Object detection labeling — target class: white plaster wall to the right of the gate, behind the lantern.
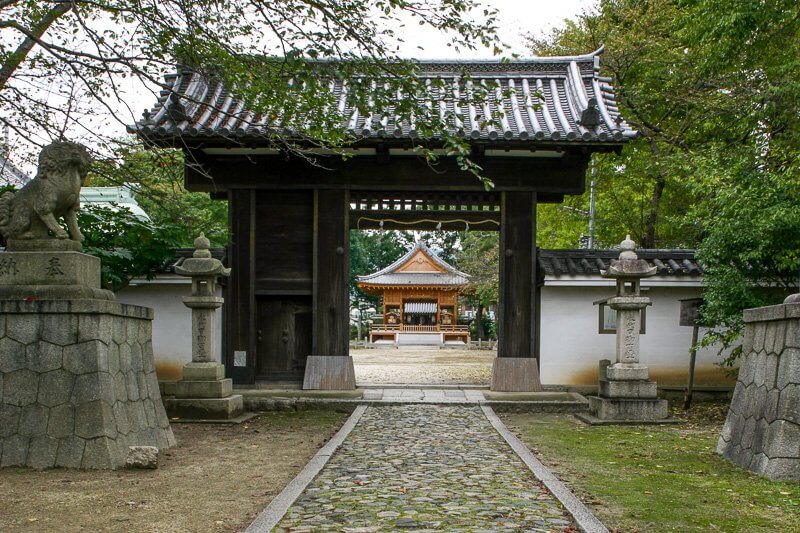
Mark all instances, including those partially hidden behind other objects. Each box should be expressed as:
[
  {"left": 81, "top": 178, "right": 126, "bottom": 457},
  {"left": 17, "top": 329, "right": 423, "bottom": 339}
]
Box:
[{"left": 541, "top": 280, "right": 733, "bottom": 385}]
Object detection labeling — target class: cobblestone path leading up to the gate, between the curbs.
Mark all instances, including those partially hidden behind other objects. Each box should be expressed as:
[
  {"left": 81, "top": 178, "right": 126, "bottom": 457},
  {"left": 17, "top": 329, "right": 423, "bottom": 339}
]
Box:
[{"left": 278, "top": 404, "right": 572, "bottom": 533}]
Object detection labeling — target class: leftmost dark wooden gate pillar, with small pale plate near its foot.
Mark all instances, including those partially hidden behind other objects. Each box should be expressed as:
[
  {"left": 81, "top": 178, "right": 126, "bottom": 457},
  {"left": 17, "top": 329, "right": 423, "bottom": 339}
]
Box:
[{"left": 223, "top": 190, "right": 256, "bottom": 383}]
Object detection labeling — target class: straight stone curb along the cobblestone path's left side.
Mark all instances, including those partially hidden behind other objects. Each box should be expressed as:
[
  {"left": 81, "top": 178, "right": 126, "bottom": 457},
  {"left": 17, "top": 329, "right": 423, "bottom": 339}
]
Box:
[{"left": 245, "top": 405, "right": 368, "bottom": 533}]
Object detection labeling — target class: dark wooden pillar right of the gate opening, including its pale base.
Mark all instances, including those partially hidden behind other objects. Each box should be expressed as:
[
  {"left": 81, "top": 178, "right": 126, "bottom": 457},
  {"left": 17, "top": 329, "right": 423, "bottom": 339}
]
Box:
[{"left": 492, "top": 191, "right": 542, "bottom": 392}]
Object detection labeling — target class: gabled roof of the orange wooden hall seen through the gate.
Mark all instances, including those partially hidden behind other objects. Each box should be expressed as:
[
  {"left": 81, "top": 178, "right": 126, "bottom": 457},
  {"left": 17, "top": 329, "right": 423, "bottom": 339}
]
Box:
[{"left": 357, "top": 241, "right": 469, "bottom": 287}]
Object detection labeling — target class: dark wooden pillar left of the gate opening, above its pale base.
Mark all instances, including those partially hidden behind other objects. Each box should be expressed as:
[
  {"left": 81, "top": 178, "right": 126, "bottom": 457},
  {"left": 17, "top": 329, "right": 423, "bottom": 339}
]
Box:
[{"left": 311, "top": 190, "right": 350, "bottom": 356}]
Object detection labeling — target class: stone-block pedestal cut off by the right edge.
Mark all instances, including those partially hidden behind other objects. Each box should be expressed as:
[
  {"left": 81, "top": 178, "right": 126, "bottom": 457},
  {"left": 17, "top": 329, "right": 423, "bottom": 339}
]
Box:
[{"left": 717, "top": 295, "right": 800, "bottom": 482}]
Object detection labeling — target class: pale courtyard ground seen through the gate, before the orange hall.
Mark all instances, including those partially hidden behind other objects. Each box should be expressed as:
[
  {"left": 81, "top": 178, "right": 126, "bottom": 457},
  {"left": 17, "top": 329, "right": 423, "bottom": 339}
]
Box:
[{"left": 350, "top": 347, "right": 497, "bottom": 386}]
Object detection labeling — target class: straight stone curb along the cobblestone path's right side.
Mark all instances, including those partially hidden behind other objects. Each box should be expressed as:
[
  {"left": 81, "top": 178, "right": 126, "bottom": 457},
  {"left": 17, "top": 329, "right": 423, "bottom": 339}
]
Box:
[{"left": 481, "top": 405, "right": 608, "bottom": 533}]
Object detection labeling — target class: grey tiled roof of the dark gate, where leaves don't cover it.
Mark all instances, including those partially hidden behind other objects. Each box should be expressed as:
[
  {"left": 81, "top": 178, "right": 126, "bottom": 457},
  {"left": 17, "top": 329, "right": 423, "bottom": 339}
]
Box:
[{"left": 129, "top": 48, "right": 637, "bottom": 146}]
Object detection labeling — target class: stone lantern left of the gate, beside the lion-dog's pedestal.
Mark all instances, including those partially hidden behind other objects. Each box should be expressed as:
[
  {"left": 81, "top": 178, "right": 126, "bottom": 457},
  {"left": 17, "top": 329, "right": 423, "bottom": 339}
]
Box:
[{"left": 166, "top": 234, "right": 243, "bottom": 419}]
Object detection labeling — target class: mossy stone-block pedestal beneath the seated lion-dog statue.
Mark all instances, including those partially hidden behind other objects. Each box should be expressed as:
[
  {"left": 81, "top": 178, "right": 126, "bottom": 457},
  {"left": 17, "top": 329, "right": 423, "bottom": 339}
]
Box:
[{"left": 0, "top": 249, "right": 175, "bottom": 469}]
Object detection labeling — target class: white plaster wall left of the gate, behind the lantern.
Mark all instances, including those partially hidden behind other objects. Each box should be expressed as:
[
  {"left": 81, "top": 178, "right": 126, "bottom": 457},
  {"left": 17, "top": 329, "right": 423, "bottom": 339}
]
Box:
[{"left": 116, "top": 276, "right": 222, "bottom": 380}]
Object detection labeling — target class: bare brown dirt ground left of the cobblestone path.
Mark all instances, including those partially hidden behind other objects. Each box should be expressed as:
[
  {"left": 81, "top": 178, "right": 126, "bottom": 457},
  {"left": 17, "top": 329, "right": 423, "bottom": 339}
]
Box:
[{"left": 0, "top": 411, "right": 348, "bottom": 532}]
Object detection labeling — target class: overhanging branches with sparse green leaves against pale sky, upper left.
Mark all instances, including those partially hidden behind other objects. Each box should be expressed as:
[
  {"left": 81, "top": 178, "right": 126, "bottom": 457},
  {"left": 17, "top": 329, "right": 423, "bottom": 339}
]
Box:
[{"left": 0, "top": 0, "right": 499, "bottom": 170}]
